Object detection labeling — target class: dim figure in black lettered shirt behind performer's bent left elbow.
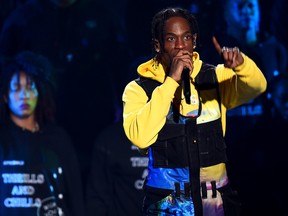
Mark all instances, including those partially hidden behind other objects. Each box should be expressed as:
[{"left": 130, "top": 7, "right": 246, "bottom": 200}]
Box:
[{"left": 86, "top": 118, "right": 148, "bottom": 216}]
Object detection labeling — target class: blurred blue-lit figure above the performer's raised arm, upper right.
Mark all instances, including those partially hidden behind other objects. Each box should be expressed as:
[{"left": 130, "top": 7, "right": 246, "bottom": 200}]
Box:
[{"left": 203, "top": 0, "right": 287, "bottom": 82}]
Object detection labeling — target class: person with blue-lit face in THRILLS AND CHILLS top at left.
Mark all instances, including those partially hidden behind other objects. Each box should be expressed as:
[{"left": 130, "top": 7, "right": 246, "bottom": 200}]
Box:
[{"left": 0, "top": 51, "right": 84, "bottom": 216}]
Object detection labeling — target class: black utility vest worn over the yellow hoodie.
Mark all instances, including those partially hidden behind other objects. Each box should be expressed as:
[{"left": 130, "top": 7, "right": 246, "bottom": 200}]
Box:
[{"left": 136, "top": 63, "right": 227, "bottom": 169}]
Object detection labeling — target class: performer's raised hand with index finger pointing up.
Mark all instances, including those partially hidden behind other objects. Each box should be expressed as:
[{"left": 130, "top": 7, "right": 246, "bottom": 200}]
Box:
[{"left": 212, "top": 36, "right": 244, "bottom": 69}]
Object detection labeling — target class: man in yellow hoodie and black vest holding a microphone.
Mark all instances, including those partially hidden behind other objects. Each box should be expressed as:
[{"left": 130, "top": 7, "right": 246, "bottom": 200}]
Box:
[{"left": 122, "top": 8, "right": 267, "bottom": 216}]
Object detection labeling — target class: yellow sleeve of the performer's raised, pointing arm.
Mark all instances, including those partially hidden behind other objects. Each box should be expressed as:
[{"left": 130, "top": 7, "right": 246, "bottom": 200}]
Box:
[{"left": 216, "top": 53, "right": 267, "bottom": 109}]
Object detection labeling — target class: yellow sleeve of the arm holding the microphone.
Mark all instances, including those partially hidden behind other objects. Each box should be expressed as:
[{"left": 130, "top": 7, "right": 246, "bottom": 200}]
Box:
[{"left": 122, "top": 77, "right": 179, "bottom": 148}]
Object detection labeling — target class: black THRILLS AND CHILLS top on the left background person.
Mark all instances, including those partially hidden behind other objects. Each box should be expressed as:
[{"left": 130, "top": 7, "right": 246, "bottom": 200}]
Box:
[{"left": 0, "top": 122, "right": 83, "bottom": 216}]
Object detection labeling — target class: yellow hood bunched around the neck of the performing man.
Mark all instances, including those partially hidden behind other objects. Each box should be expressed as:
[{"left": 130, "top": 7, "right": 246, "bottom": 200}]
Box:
[{"left": 137, "top": 52, "right": 202, "bottom": 83}]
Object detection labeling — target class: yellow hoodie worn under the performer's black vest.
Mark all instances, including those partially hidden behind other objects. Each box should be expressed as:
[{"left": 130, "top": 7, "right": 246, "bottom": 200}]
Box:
[{"left": 122, "top": 52, "right": 267, "bottom": 149}]
